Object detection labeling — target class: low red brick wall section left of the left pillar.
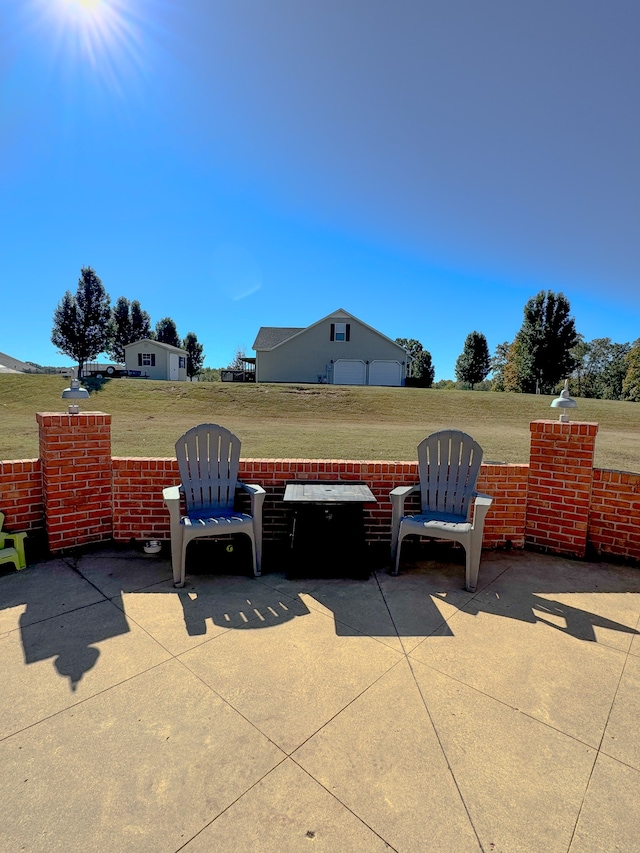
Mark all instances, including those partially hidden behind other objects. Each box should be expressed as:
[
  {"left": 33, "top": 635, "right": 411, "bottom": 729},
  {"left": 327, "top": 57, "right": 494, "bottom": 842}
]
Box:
[{"left": 0, "top": 459, "right": 44, "bottom": 532}]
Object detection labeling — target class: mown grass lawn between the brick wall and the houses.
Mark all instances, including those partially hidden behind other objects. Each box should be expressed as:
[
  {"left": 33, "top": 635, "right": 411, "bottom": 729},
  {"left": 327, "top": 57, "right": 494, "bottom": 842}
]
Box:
[{"left": 0, "top": 374, "right": 640, "bottom": 471}]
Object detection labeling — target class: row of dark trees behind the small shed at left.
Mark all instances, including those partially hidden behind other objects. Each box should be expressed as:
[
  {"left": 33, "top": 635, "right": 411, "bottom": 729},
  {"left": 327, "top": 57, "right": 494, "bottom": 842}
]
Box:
[{"left": 51, "top": 267, "right": 205, "bottom": 379}]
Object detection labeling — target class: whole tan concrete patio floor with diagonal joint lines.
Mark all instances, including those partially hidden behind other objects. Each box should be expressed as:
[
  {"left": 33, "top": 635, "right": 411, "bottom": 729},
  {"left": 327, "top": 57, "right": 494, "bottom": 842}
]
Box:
[{"left": 0, "top": 550, "right": 640, "bottom": 853}]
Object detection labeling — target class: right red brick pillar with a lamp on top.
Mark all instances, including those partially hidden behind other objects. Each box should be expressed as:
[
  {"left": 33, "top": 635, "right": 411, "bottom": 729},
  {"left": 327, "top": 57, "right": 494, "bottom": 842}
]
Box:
[{"left": 525, "top": 420, "right": 598, "bottom": 557}]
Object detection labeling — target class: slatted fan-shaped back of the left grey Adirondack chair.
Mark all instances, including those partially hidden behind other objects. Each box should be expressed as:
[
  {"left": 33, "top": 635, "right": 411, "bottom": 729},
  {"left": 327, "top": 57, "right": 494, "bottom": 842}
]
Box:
[{"left": 176, "top": 424, "right": 240, "bottom": 512}]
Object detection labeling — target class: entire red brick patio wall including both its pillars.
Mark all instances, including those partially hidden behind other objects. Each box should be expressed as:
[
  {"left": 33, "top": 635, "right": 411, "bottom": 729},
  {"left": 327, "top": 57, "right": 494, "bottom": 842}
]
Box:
[{"left": 0, "top": 412, "right": 640, "bottom": 561}]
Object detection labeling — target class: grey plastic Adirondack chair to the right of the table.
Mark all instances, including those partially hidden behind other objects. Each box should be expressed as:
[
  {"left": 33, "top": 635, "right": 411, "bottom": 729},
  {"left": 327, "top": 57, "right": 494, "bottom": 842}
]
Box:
[{"left": 389, "top": 430, "right": 493, "bottom": 592}]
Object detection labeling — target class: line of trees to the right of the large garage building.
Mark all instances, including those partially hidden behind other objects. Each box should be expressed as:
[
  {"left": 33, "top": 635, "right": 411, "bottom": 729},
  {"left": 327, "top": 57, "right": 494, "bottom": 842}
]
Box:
[{"left": 396, "top": 290, "right": 640, "bottom": 401}]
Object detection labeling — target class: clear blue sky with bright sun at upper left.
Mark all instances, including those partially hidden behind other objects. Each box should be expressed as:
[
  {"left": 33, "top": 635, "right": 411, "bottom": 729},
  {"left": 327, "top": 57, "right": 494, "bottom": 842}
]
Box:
[{"left": 0, "top": 0, "right": 640, "bottom": 380}]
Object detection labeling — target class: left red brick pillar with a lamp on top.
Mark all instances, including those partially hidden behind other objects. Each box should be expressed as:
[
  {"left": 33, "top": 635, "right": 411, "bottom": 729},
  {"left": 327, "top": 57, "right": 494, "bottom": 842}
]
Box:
[{"left": 36, "top": 412, "right": 113, "bottom": 551}]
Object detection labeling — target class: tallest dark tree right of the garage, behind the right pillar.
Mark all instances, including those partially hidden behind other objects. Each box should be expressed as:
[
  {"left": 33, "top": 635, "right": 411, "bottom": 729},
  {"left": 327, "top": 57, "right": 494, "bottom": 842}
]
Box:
[{"left": 514, "top": 290, "right": 578, "bottom": 394}]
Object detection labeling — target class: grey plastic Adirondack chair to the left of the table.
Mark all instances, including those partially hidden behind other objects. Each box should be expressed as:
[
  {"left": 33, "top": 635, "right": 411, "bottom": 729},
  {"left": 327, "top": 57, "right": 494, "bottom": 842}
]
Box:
[{"left": 162, "top": 424, "right": 266, "bottom": 587}]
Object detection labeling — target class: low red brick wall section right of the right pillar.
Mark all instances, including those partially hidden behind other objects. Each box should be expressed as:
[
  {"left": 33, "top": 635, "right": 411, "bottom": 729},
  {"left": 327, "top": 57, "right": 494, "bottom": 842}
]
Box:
[{"left": 589, "top": 468, "right": 640, "bottom": 560}]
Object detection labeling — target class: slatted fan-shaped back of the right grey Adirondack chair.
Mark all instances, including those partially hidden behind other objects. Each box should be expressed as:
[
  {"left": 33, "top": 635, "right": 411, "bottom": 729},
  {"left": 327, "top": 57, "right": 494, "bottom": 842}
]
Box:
[{"left": 418, "top": 429, "right": 482, "bottom": 518}]
